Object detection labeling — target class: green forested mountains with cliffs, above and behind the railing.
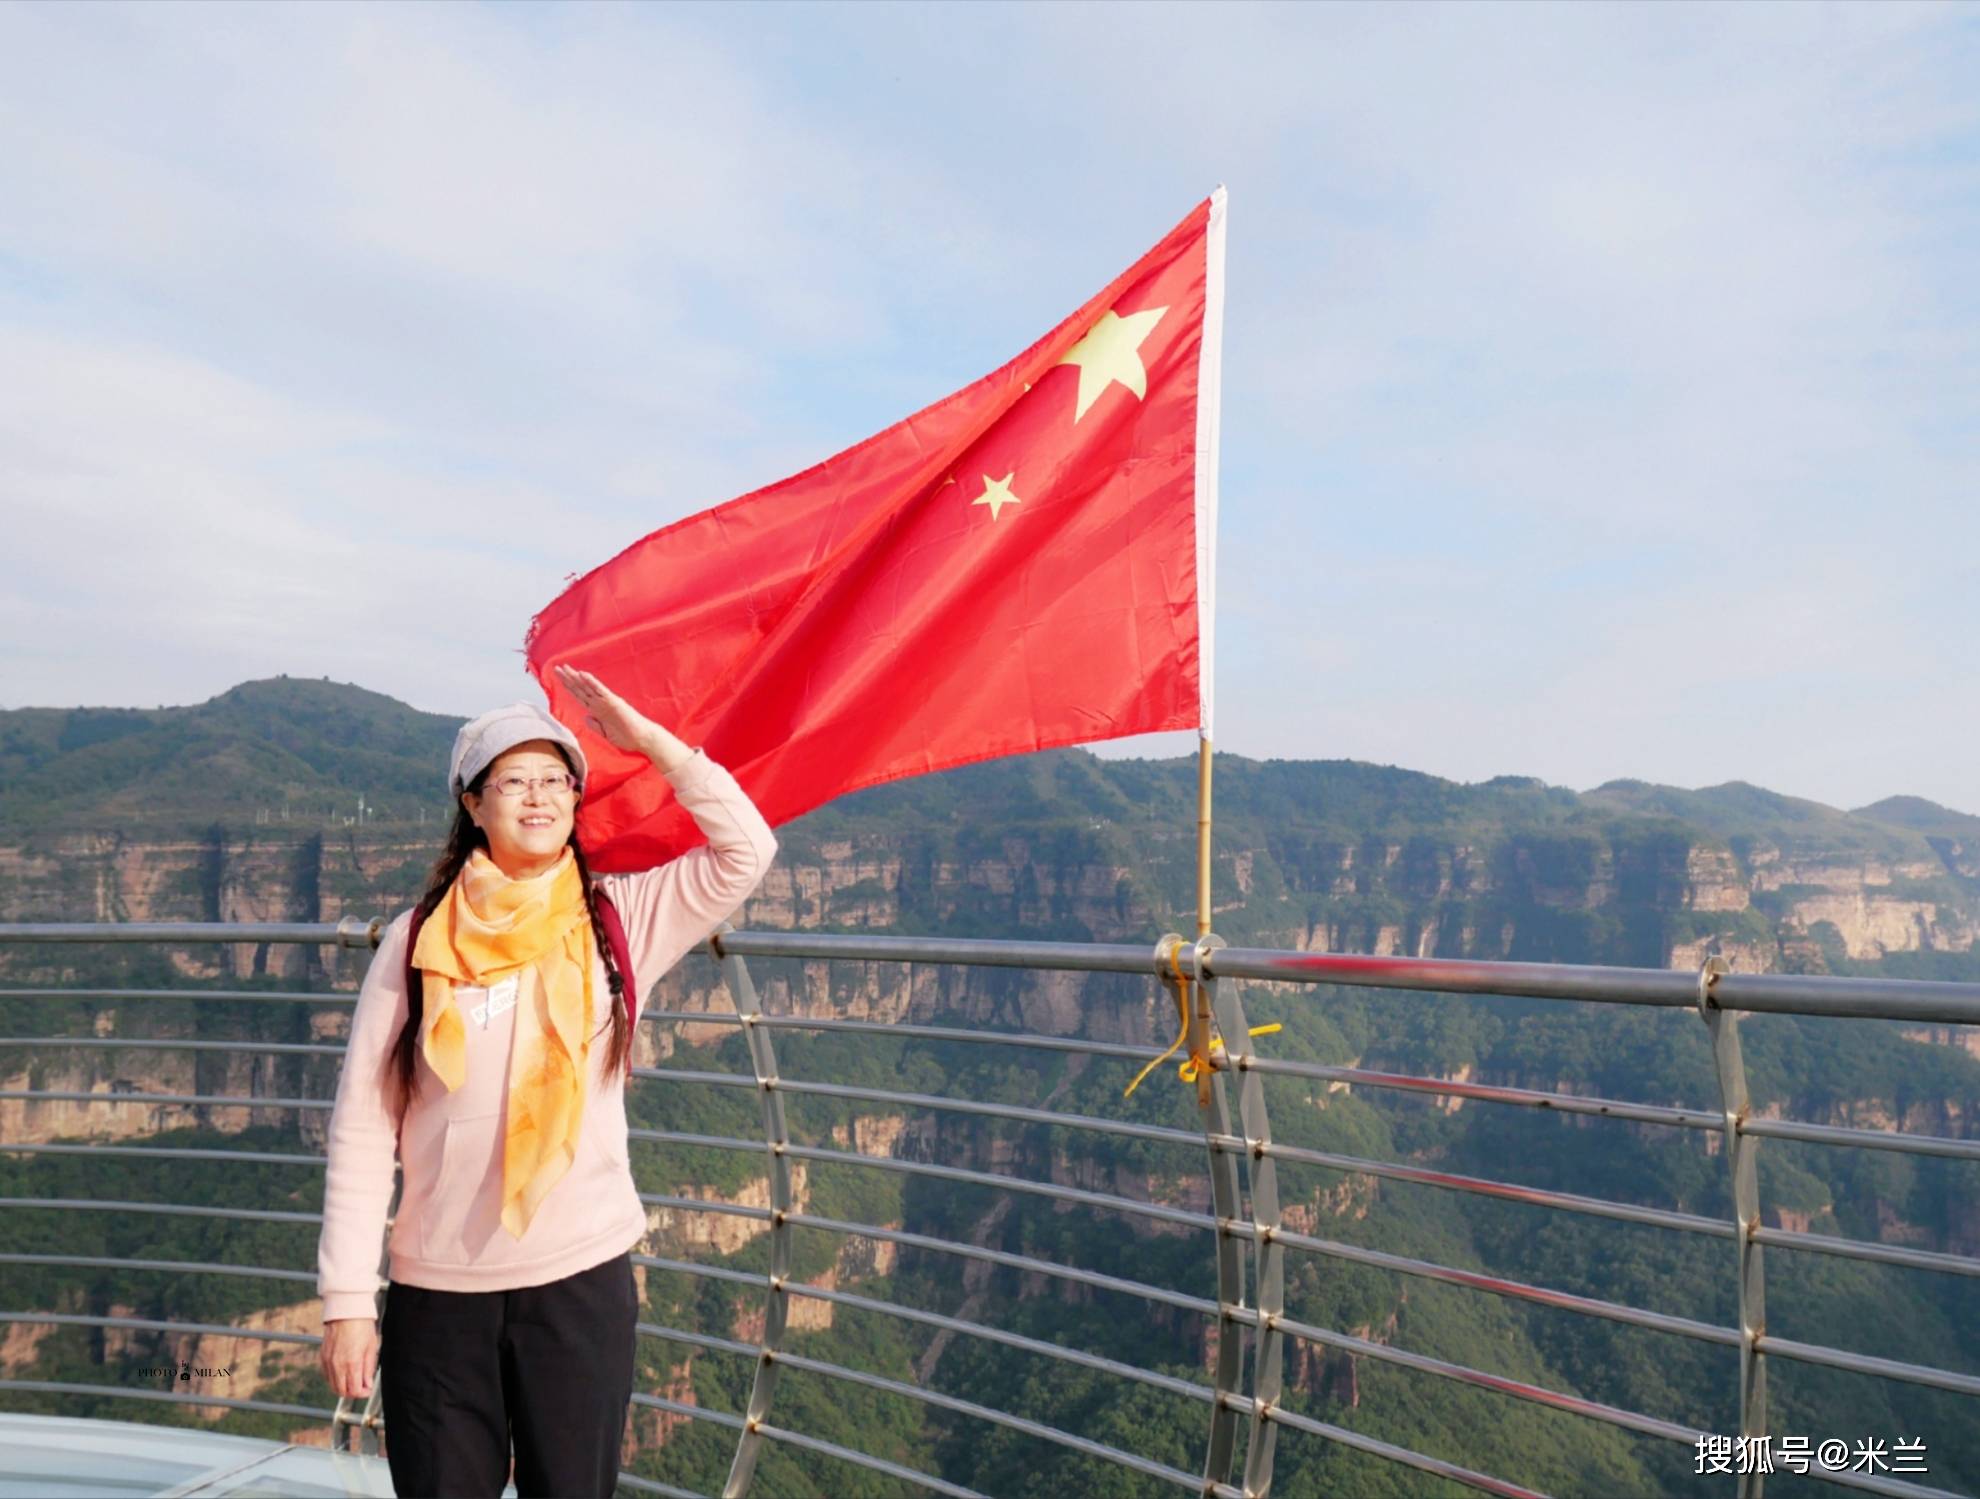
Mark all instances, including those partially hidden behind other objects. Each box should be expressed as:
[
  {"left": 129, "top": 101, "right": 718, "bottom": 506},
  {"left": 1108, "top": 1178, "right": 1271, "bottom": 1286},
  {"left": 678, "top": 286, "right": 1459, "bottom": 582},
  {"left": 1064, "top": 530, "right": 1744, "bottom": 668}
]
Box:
[{"left": 0, "top": 679, "right": 1980, "bottom": 1499}]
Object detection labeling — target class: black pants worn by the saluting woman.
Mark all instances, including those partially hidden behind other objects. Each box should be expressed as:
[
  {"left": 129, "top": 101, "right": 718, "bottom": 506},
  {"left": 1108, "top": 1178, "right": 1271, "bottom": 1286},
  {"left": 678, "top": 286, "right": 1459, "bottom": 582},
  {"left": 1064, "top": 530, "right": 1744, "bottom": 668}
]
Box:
[{"left": 378, "top": 1255, "right": 638, "bottom": 1499}]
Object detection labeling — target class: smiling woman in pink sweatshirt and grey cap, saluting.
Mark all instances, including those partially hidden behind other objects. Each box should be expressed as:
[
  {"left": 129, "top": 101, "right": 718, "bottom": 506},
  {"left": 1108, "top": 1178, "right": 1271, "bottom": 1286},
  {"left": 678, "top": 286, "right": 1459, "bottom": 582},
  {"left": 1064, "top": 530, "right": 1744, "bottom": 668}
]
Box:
[{"left": 317, "top": 667, "right": 776, "bottom": 1495}]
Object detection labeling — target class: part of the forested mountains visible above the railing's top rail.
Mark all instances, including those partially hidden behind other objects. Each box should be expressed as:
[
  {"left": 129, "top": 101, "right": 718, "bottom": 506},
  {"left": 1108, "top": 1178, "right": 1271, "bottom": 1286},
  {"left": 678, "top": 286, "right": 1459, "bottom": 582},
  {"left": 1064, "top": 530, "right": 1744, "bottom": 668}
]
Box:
[{"left": 0, "top": 677, "right": 1980, "bottom": 976}]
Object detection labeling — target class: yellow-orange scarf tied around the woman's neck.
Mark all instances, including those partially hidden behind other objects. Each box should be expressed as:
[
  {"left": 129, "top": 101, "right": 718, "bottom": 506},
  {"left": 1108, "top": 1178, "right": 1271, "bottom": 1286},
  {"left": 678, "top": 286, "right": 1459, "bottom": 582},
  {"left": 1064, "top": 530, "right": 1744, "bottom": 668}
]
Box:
[{"left": 412, "top": 848, "right": 592, "bottom": 1238}]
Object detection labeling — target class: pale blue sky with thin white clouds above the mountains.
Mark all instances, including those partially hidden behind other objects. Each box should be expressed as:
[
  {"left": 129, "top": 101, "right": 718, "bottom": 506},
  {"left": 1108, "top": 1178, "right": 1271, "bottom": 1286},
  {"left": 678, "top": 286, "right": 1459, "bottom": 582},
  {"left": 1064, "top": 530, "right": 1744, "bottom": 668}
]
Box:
[{"left": 0, "top": 2, "right": 1980, "bottom": 810}]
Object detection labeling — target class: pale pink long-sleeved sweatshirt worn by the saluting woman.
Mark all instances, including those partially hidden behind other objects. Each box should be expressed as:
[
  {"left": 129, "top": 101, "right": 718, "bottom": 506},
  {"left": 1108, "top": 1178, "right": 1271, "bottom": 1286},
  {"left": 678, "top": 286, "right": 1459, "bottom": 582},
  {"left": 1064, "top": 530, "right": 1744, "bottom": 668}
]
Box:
[{"left": 317, "top": 750, "right": 776, "bottom": 1323}]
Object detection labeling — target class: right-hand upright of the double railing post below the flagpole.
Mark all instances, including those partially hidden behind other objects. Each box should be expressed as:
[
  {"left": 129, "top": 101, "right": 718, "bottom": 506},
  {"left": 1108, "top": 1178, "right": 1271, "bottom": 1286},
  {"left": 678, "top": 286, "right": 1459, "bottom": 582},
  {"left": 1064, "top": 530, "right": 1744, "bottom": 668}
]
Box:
[{"left": 1196, "top": 935, "right": 1285, "bottom": 1499}]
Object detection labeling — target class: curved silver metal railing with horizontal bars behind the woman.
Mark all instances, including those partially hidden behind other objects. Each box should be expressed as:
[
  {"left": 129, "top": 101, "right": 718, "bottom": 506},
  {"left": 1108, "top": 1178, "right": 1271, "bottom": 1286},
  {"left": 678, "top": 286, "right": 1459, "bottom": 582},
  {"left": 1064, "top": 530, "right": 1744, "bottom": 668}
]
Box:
[{"left": 0, "top": 921, "right": 1980, "bottom": 1499}]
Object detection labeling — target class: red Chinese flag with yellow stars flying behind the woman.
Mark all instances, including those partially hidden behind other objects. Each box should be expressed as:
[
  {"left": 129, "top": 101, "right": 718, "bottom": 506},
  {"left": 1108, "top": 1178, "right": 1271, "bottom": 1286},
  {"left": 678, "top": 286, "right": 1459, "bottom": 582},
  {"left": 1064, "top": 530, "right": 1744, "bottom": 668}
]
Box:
[{"left": 529, "top": 188, "right": 1224, "bottom": 869}]
